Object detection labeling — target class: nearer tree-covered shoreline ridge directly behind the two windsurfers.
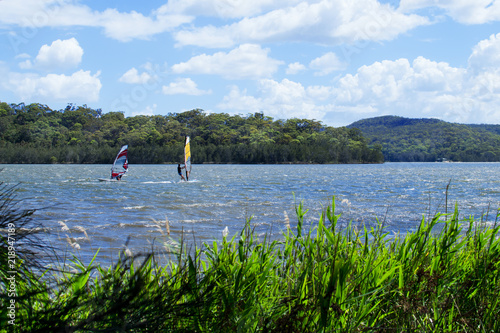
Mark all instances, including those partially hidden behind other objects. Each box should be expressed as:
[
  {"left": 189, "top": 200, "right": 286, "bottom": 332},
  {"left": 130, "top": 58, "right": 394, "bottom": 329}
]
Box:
[{"left": 0, "top": 103, "right": 383, "bottom": 164}]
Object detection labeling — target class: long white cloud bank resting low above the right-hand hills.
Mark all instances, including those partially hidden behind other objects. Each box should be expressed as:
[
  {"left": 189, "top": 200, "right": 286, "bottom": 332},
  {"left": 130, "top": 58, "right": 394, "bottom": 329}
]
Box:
[{"left": 219, "top": 35, "right": 500, "bottom": 126}]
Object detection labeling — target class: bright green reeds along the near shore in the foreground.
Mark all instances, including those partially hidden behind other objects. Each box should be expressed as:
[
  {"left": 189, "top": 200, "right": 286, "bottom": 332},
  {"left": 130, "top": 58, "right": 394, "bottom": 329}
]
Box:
[{"left": 0, "top": 199, "right": 500, "bottom": 332}]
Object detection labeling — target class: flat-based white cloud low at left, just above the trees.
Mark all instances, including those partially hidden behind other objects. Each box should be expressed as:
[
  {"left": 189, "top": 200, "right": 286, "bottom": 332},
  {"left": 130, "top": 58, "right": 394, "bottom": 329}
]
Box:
[{"left": 3, "top": 70, "right": 102, "bottom": 103}]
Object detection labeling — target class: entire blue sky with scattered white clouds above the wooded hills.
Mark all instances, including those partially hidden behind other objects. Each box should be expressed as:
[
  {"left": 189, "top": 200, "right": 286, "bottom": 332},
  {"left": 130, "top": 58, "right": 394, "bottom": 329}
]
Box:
[{"left": 0, "top": 0, "right": 500, "bottom": 126}]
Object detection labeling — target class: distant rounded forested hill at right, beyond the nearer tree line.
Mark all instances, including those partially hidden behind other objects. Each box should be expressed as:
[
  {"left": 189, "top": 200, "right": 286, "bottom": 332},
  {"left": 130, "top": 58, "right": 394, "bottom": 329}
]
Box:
[{"left": 348, "top": 116, "right": 500, "bottom": 162}]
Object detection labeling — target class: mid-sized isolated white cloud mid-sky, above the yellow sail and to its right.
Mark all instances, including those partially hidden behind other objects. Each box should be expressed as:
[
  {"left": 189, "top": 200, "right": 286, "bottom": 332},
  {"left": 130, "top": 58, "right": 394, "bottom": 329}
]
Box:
[{"left": 172, "top": 44, "right": 283, "bottom": 79}]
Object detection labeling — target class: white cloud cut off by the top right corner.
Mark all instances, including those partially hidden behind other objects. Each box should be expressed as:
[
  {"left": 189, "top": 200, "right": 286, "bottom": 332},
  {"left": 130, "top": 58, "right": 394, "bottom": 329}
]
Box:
[{"left": 399, "top": 0, "right": 500, "bottom": 24}]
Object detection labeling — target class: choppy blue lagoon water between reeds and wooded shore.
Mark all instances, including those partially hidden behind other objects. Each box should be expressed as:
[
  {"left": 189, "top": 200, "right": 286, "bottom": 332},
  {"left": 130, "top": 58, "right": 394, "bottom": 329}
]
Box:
[{"left": 0, "top": 163, "right": 500, "bottom": 261}]
